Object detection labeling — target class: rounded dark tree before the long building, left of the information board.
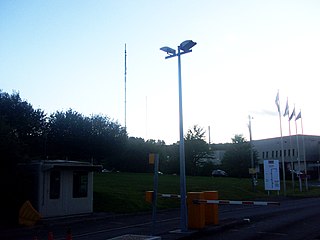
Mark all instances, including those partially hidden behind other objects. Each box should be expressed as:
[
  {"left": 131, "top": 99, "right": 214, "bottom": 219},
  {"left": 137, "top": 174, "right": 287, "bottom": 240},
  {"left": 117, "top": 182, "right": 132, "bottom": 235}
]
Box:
[{"left": 222, "top": 134, "right": 258, "bottom": 177}]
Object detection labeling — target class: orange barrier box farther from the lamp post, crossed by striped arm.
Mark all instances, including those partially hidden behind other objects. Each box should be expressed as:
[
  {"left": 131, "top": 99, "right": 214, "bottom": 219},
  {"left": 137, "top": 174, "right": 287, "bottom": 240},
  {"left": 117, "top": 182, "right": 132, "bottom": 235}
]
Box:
[{"left": 203, "top": 191, "right": 219, "bottom": 225}]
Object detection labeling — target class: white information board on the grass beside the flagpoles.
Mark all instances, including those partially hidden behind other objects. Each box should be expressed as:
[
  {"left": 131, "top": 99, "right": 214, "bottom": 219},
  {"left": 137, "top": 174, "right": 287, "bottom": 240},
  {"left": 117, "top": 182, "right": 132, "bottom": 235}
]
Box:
[{"left": 263, "top": 160, "right": 280, "bottom": 191}]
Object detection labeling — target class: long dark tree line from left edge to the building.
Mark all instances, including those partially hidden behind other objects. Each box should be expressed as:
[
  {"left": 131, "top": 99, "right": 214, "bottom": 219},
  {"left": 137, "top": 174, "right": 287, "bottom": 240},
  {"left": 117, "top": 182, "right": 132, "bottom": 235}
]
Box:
[{"left": 0, "top": 90, "right": 258, "bottom": 225}]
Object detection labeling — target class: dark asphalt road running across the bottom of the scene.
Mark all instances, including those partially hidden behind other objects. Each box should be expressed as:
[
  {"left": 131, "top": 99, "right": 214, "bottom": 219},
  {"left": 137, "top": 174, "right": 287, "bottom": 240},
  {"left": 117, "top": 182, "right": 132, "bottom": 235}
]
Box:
[{"left": 0, "top": 198, "right": 320, "bottom": 240}]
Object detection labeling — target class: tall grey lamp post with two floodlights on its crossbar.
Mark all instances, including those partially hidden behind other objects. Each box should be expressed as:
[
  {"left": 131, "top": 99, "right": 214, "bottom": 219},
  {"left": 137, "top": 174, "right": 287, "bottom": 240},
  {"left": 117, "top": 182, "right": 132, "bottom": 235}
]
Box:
[{"left": 160, "top": 40, "right": 197, "bottom": 232}]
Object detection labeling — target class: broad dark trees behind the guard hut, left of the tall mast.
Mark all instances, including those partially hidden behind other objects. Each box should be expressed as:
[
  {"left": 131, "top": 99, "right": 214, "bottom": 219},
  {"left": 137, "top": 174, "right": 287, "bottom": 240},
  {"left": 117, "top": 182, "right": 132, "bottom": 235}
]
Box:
[{"left": 48, "top": 109, "right": 127, "bottom": 163}]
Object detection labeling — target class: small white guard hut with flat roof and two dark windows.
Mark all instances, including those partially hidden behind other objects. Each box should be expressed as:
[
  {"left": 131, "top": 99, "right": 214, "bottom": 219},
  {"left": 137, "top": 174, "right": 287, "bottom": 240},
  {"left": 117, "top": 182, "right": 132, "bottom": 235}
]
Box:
[{"left": 17, "top": 160, "right": 102, "bottom": 218}]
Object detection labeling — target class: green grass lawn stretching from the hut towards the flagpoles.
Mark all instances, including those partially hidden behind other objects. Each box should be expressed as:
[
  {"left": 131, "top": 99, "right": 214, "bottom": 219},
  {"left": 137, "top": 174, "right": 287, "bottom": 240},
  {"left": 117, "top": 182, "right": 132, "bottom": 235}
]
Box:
[{"left": 93, "top": 173, "right": 320, "bottom": 213}]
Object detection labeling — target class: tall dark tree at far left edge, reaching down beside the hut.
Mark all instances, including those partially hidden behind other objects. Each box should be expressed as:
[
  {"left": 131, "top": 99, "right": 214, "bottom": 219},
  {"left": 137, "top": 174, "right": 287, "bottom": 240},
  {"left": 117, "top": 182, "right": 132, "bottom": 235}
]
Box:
[{"left": 0, "top": 90, "right": 46, "bottom": 224}]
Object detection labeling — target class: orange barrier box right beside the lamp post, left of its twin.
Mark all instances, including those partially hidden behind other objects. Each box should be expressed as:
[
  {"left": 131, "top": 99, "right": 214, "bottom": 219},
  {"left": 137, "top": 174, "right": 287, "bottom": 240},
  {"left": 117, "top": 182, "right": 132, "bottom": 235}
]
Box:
[{"left": 187, "top": 192, "right": 205, "bottom": 229}]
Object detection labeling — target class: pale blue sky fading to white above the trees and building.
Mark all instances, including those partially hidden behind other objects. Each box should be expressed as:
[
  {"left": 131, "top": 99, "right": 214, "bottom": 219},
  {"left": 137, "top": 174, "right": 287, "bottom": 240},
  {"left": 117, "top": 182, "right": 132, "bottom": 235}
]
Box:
[{"left": 0, "top": 0, "right": 320, "bottom": 144}]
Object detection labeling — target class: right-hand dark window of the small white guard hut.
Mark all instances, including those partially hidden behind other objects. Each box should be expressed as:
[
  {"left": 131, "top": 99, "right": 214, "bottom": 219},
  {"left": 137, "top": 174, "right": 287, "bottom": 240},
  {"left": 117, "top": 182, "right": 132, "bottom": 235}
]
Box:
[{"left": 73, "top": 171, "right": 88, "bottom": 198}]
